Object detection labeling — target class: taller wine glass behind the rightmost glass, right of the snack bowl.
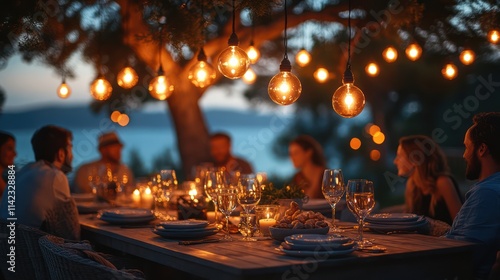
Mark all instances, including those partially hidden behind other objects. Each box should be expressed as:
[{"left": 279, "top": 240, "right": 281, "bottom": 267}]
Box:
[{"left": 321, "top": 169, "right": 345, "bottom": 233}]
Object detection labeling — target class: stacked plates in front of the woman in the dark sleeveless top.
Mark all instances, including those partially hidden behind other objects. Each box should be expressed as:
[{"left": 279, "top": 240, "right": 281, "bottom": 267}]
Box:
[{"left": 365, "top": 213, "right": 429, "bottom": 232}]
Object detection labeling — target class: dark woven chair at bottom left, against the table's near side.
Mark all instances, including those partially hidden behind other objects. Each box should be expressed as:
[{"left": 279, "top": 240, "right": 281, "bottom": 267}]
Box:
[{"left": 39, "top": 235, "right": 144, "bottom": 280}]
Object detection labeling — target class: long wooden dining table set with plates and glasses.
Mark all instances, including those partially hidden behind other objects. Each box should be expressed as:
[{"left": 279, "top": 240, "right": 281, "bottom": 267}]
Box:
[{"left": 80, "top": 214, "right": 474, "bottom": 280}]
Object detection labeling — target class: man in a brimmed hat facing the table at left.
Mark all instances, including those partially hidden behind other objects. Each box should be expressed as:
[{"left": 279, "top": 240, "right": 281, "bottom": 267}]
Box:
[{"left": 71, "top": 132, "right": 134, "bottom": 193}]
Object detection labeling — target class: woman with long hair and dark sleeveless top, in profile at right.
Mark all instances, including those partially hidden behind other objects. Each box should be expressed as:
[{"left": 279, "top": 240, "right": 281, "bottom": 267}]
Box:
[{"left": 394, "top": 135, "right": 463, "bottom": 225}]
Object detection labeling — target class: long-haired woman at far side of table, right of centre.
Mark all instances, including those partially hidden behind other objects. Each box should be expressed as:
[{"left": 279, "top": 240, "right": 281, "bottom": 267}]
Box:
[{"left": 288, "top": 135, "right": 326, "bottom": 198}]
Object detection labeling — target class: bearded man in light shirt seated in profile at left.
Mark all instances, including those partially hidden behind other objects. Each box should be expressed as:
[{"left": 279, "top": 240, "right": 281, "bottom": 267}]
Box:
[{"left": 0, "top": 125, "right": 80, "bottom": 240}]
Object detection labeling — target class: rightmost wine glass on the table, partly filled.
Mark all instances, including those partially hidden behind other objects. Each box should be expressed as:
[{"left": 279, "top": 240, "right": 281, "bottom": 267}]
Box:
[{"left": 346, "top": 179, "right": 375, "bottom": 248}]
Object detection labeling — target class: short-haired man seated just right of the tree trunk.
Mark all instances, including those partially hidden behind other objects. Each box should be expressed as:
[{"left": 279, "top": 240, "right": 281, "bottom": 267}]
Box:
[{"left": 210, "top": 133, "right": 253, "bottom": 174}]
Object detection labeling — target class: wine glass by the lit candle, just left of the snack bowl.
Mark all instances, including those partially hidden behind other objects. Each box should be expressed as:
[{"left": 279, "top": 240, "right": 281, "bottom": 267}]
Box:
[{"left": 237, "top": 174, "right": 261, "bottom": 241}]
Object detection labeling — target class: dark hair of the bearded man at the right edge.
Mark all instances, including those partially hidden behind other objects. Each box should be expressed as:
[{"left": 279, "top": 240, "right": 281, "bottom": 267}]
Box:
[{"left": 469, "top": 112, "right": 500, "bottom": 163}]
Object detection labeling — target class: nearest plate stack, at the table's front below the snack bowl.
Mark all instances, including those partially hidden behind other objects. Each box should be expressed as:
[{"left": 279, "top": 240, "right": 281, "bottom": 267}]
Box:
[{"left": 279, "top": 234, "right": 356, "bottom": 257}]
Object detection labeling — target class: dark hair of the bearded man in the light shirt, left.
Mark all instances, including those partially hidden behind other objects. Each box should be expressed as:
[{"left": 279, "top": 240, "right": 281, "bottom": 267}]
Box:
[{"left": 31, "top": 125, "right": 73, "bottom": 163}]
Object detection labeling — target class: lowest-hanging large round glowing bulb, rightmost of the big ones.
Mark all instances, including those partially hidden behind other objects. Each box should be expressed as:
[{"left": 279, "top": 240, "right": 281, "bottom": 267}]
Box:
[{"left": 332, "top": 83, "right": 365, "bottom": 118}]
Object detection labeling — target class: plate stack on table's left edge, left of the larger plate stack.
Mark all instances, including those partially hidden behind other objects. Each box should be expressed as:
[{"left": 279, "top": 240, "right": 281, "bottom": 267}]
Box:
[{"left": 97, "top": 208, "right": 155, "bottom": 224}]
